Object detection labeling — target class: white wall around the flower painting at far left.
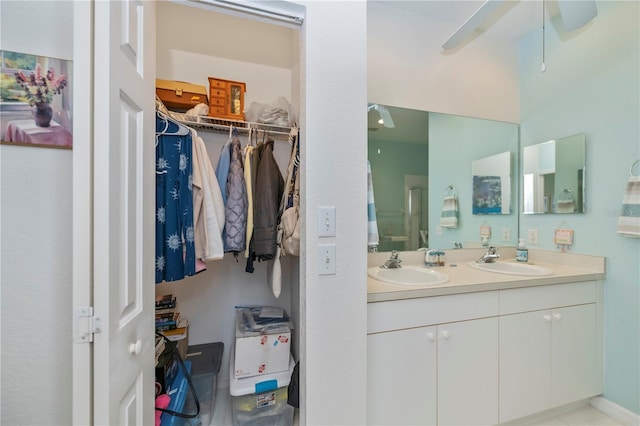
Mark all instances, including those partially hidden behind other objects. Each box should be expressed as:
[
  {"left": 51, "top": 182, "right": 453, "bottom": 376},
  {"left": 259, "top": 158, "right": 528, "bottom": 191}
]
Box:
[{"left": 0, "top": 1, "right": 73, "bottom": 425}]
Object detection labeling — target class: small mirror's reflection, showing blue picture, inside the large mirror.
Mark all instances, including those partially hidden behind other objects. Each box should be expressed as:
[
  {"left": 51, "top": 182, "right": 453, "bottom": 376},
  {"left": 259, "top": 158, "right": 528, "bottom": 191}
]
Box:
[{"left": 471, "top": 151, "right": 511, "bottom": 214}]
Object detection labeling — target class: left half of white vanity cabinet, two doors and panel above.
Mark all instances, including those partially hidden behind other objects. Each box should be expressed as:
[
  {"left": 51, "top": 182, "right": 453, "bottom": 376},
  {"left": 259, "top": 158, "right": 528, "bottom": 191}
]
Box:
[{"left": 367, "top": 291, "right": 498, "bottom": 425}]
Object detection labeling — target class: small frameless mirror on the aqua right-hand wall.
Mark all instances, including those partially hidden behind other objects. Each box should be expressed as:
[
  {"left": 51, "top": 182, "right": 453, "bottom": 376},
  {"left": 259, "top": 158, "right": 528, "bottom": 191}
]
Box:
[{"left": 522, "top": 133, "right": 586, "bottom": 214}]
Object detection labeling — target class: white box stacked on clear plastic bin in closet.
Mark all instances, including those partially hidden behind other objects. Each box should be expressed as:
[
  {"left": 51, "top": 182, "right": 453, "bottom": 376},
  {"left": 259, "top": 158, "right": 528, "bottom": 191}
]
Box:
[{"left": 233, "top": 306, "right": 291, "bottom": 378}]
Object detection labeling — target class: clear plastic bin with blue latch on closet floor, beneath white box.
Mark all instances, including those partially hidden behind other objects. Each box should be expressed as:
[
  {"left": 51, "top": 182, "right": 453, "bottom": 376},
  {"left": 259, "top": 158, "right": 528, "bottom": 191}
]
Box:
[{"left": 229, "top": 342, "right": 295, "bottom": 426}]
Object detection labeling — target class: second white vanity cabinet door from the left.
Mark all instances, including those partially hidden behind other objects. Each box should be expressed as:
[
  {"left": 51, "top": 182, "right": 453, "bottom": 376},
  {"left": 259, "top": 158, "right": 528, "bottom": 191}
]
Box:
[{"left": 438, "top": 317, "right": 499, "bottom": 425}]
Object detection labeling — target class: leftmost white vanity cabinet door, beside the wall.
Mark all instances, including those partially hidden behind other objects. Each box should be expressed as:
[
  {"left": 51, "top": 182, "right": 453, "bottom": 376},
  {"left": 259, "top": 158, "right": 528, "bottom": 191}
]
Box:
[{"left": 368, "top": 327, "right": 436, "bottom": 425}]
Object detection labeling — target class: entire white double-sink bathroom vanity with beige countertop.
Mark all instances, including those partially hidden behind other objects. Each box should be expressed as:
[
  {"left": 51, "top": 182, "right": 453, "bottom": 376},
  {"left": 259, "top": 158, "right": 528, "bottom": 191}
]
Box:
[{"left": 367, "top": 248, "right": 605, "bottom": 425}]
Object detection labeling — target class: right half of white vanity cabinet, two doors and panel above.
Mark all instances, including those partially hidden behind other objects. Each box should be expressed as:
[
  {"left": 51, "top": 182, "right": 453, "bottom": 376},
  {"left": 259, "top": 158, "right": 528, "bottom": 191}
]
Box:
[{"left": 500, "top": 281, "right": 602, "bottom": 422}]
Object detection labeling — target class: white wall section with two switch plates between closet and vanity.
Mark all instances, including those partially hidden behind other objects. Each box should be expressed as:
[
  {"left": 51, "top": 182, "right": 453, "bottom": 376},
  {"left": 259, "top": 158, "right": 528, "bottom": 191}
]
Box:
[{"left": 300, "top": 1, "right": 369, "bottom": 425}]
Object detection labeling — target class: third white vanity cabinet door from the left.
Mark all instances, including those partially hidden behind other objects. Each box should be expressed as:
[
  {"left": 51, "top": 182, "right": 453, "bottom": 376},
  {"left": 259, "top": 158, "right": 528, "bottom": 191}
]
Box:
[{"left": 500, "top": 310, "right": 551, "bottom": 423}]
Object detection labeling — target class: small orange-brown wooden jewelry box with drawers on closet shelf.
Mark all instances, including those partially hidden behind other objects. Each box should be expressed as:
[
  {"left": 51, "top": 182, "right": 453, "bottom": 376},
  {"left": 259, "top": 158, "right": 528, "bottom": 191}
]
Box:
[{"left": 209, "top": 77, "right": 247, "bottom": 121}]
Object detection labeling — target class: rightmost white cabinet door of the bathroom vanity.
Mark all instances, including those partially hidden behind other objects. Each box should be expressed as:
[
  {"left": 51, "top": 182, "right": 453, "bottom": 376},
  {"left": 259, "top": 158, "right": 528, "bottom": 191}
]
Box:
[{"left": 551, "top": 303, "right": 600, "bottom": 407}]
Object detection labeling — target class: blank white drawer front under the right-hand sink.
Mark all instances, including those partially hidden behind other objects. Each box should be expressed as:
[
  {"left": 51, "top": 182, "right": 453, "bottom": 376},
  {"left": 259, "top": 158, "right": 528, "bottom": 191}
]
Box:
[{"left": 500, "top": 281, "right": 596, "bottom": 315}]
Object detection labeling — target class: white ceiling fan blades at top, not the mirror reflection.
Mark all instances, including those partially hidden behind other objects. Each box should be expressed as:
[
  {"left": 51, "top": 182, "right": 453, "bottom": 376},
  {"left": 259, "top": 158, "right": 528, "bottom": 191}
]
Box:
[{"left": 442, "top": 0, "right": 598, "bottom": 49}]
